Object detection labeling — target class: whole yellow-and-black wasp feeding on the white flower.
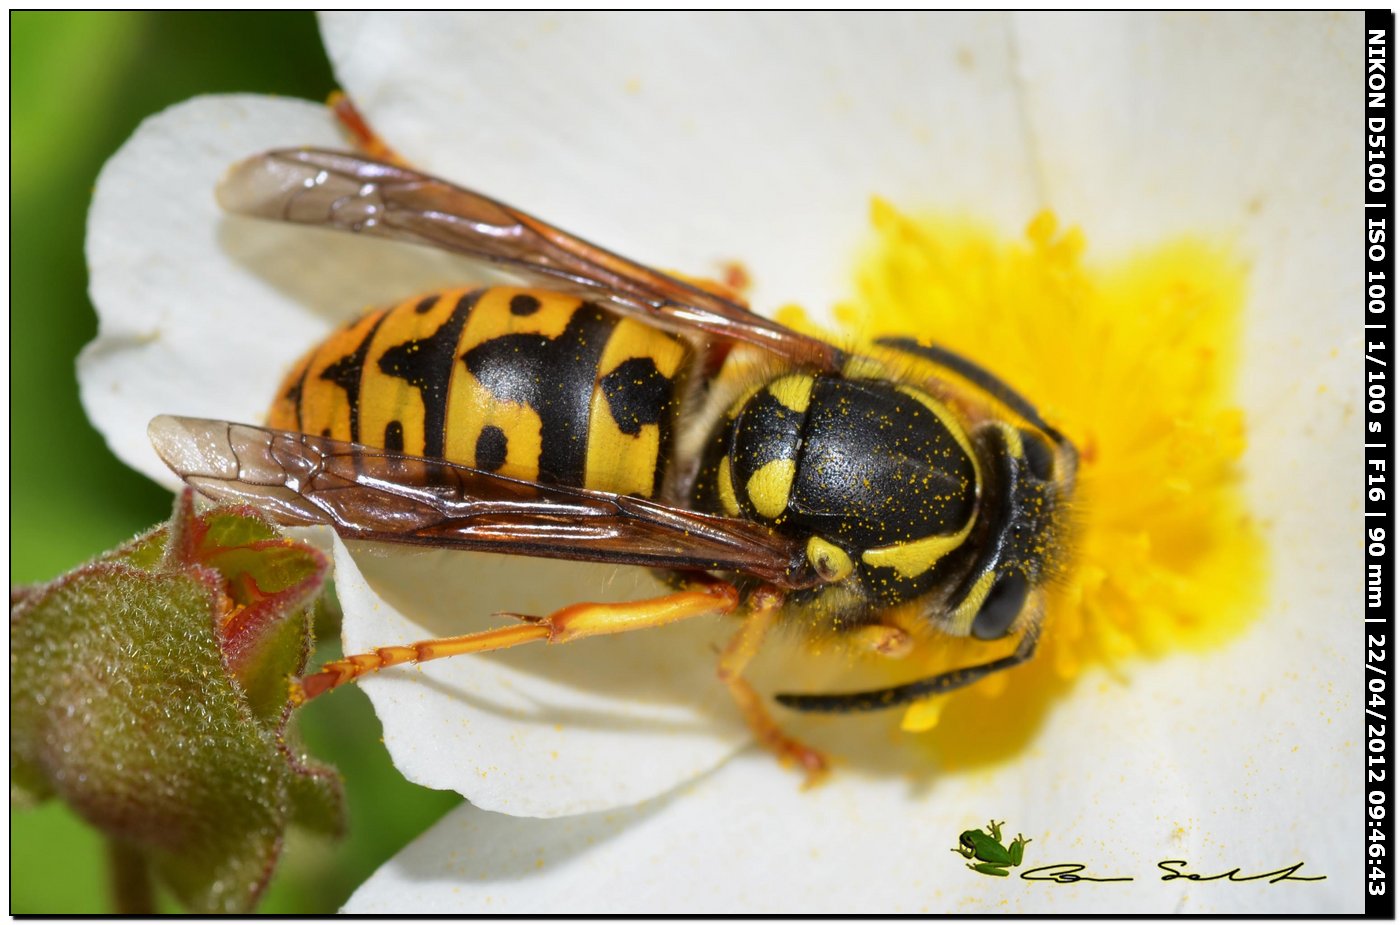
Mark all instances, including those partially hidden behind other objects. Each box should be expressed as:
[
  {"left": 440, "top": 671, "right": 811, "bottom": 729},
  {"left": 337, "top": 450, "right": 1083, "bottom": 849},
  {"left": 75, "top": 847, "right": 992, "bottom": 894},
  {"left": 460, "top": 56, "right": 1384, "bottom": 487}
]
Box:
[{"left": 151, "top": 142, "right": 1078, "bottom": 777}]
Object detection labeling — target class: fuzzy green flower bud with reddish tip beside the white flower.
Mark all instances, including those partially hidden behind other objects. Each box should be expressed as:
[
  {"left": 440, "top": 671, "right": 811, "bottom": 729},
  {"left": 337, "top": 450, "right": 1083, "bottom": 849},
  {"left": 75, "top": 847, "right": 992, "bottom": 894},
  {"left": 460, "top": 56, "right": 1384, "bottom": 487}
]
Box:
[{"left": 10, "top": 489, "right": 343, "bottom": 912}]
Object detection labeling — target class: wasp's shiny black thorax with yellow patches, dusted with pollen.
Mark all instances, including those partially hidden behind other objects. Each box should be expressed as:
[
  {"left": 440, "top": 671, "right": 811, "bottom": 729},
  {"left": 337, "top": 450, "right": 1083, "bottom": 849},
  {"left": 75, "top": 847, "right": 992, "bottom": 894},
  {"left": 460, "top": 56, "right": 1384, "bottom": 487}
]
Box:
[{"left": 697, "top": 372, "right": 979, "bottom": 600}]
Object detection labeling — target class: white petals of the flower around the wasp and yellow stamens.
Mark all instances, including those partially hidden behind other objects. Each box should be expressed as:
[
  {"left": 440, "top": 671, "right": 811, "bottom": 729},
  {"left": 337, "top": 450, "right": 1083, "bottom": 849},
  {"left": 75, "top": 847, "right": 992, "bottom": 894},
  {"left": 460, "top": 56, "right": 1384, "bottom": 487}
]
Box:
[{"left": 80, "top": 14, "right": 1362, "bottom": 914}]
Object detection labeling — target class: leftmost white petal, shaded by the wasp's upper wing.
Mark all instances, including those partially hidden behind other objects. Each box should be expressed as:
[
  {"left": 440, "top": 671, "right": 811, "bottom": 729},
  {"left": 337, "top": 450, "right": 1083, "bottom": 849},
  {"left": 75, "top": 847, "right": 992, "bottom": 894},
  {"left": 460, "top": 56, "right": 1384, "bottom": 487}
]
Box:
[{"left": 78, "top": 97, "right": 481, "bottom": 486}]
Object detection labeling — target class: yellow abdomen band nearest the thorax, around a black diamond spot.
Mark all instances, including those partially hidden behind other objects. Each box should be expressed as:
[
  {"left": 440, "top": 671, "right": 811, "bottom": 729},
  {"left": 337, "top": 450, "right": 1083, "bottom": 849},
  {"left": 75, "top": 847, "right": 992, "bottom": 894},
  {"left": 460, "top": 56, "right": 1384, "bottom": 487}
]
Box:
[{"left": 584, "top": 319, "right": 686, "bottom": 497}]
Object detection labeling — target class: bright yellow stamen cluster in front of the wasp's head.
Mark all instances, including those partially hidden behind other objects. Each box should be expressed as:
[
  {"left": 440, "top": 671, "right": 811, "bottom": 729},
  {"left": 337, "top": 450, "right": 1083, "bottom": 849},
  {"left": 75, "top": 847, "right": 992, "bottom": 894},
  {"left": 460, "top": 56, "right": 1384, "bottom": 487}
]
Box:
[{"left": 784, "top": 202, "right": 1264, "bottom": 764}]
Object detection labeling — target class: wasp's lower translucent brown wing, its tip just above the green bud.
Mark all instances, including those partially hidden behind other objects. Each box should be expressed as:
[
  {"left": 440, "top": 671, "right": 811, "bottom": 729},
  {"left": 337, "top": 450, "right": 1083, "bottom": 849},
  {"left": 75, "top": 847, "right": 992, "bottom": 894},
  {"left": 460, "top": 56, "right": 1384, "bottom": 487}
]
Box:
[{"left": 150, "top": 416, "right": 816, "bottom": 588}]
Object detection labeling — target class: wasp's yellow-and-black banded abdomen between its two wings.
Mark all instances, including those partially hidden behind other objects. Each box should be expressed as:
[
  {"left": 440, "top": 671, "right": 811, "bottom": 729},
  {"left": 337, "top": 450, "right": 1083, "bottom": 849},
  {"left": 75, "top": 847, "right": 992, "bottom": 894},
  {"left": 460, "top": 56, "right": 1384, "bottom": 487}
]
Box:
[{"left": 269, "top": 287, "right": 690, "bottom": 497}]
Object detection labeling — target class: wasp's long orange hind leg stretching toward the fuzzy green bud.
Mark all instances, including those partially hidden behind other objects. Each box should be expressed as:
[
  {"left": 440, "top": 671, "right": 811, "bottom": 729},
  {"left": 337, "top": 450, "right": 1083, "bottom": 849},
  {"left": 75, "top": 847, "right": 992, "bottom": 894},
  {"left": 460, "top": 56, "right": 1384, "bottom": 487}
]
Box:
[{"left": 294, "top": 577, "right": 739, "bottom": 702}]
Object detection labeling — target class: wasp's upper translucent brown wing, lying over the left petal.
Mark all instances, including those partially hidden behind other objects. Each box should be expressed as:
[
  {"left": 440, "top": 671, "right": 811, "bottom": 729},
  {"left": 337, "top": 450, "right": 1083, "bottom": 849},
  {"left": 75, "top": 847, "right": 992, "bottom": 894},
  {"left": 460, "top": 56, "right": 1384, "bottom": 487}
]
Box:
[{"left": 217, "top": 148, "right": 844, "bottom": 371}]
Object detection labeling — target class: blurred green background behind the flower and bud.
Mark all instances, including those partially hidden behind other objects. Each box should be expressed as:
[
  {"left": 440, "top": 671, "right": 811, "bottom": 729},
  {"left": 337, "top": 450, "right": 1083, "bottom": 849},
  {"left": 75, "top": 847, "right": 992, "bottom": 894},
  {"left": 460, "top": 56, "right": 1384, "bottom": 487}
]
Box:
[{"left": 10, "top": 13, "right": 459, "bottom": 914}]
